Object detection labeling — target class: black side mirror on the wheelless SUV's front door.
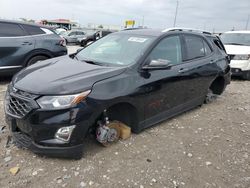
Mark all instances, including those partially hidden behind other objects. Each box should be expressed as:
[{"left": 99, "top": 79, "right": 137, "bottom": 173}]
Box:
[{"left": 142, "top": 59, "right": 172, "bottom": 70}]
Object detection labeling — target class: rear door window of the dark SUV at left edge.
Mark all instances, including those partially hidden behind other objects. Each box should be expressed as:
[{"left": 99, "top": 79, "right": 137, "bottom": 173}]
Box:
[{"left": 0, "top": 23, "right": 26, "bottom": 37}]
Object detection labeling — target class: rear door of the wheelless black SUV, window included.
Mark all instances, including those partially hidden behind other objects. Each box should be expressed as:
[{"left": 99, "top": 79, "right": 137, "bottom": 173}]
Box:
[{"left": 181, "top": 34, "right": 217, "bottom": 101}]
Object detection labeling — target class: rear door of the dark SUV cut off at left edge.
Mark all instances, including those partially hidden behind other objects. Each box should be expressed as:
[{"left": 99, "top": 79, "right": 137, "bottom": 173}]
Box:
[{"left": 0, "top": 22, "right": 34, "bottom": 71}]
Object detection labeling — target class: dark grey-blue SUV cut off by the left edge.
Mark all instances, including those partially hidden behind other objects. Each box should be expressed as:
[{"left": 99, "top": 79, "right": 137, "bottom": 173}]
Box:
[{"left": 0, "top": 20, "right": 67, "bottom": 75}]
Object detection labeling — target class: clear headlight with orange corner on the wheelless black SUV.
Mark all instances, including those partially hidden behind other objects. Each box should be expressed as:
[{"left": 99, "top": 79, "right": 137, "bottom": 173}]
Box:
[{"left": 37, "top": 90, "right": 90, "bottom": 109}]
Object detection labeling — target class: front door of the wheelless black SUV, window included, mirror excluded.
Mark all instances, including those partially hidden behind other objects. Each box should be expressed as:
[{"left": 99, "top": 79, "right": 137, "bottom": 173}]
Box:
[{"left": 143, "top": 35, "right": 189, "bottom": 127}]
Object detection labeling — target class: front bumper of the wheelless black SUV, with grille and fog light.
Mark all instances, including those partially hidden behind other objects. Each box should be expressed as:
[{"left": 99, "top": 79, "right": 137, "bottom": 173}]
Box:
[{"left": 5, "top": 86, "right": 93, "bottom": 158}]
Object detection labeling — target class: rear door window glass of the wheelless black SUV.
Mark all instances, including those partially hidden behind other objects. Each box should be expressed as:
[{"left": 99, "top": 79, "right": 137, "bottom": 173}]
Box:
[{"left": 185, "top": 35, "right": 205, "bottom": 60}]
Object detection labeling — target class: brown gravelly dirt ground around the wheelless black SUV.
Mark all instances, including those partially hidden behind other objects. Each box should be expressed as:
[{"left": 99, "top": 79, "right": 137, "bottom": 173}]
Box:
[{"left": 0, "top": 80, "right": 250, "bottom": 188}]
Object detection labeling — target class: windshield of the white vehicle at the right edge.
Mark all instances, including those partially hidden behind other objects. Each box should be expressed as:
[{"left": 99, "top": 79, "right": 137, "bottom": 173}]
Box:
[{"left": 220, "top": 33, "right": 250, "bottom": 46}]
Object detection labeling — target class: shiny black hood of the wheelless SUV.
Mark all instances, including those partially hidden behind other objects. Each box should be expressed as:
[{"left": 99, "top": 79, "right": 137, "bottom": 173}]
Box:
[{"left": 13, "top": 56, "right": 126, "bottom": 95}]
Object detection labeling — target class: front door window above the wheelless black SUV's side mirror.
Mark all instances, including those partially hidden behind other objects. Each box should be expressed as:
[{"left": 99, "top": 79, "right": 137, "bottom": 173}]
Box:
[{"left": 149, "top": 36, "right": 182, "bottom": 65}]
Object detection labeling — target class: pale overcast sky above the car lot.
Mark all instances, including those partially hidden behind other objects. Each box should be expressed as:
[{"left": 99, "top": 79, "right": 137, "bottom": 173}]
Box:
[{"left": 0, "top": 0, "right": 250, "bottom": 32}]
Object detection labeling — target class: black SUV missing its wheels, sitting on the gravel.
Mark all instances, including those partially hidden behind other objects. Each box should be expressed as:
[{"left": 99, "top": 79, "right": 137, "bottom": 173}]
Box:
[{"left": 5, "top": 29, "right": 231, "bottom": 158}]
